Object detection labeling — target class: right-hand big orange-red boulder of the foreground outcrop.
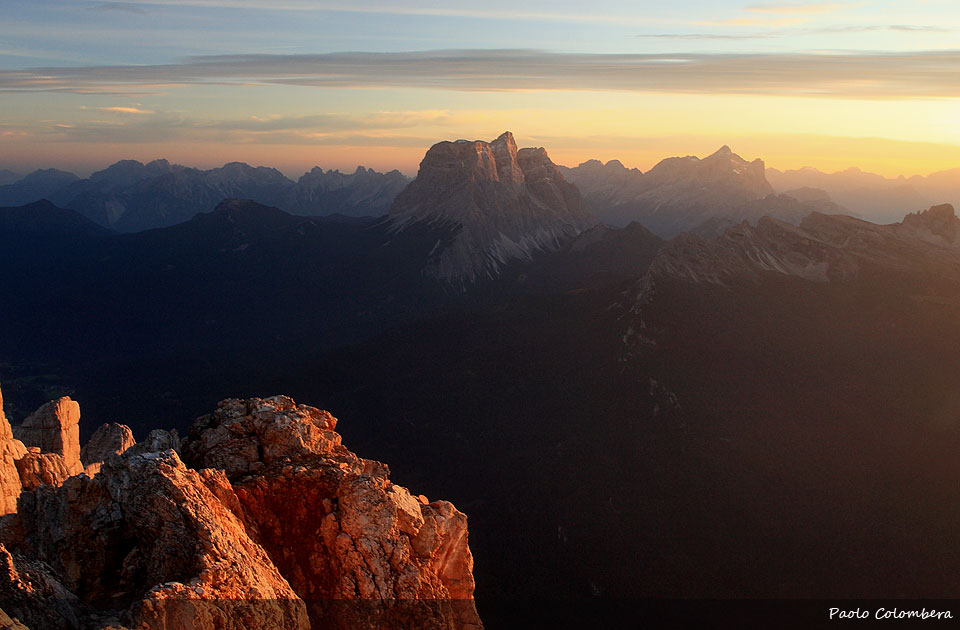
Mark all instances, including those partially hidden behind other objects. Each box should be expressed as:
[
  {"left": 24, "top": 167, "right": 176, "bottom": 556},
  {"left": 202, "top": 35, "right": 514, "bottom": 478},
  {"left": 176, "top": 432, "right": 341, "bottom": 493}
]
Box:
[{"left": 184, "top": 396, "right": 480, "bottom": 628}]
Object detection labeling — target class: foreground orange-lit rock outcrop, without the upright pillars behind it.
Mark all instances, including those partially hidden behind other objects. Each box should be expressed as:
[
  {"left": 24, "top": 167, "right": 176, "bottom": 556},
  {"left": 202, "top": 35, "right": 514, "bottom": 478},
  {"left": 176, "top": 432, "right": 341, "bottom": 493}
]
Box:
[{"left": 0, "top": 396, "right": 482, "bottom": 630}]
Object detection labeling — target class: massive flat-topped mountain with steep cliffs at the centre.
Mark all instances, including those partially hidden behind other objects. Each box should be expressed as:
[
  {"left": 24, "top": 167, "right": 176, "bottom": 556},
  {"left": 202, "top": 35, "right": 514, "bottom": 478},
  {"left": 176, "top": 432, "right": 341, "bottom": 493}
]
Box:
[{"left": 390, "top": 131, "right": 593, "bottom": 286}]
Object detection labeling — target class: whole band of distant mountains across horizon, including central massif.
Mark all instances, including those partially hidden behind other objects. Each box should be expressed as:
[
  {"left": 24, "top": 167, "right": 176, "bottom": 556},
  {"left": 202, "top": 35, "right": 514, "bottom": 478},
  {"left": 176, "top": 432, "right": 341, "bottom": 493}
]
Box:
[{"left": 0, "top": 144, "right": 960, "bottom": 241}]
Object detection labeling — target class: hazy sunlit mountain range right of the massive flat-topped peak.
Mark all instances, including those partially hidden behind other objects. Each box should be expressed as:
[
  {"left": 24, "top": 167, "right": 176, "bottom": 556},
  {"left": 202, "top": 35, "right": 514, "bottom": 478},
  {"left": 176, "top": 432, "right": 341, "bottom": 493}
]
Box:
[{"left": 560, "top": 147, "right": 960, "bottom": 238}]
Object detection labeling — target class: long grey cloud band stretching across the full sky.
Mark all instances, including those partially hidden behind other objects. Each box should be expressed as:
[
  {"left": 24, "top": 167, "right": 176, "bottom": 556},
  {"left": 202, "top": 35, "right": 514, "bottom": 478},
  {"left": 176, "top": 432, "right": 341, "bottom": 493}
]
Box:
[{"left": 0, "top": 50, "right": 960, "bottom": 99}]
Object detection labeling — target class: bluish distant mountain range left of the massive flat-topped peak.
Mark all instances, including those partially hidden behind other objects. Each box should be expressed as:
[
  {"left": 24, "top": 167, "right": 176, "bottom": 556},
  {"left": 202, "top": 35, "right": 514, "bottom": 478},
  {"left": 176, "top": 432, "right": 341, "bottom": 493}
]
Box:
[{"left": 0, "top": 160, "right": 409, "bottom": 232}]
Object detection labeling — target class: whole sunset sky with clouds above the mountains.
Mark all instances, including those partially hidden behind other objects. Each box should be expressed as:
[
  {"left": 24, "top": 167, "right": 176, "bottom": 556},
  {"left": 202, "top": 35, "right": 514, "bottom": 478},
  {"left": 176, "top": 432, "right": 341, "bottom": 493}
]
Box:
[{"left": 0, "top": 0, "right": 960, "bottom": 177}]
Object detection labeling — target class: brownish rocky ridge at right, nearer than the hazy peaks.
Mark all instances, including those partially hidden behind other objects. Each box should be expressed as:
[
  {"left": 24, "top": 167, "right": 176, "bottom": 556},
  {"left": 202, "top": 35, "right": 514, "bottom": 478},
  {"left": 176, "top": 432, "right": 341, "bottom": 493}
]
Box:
[{"left": 621, "top": 204, "right": 960, "bottom": 361}]
